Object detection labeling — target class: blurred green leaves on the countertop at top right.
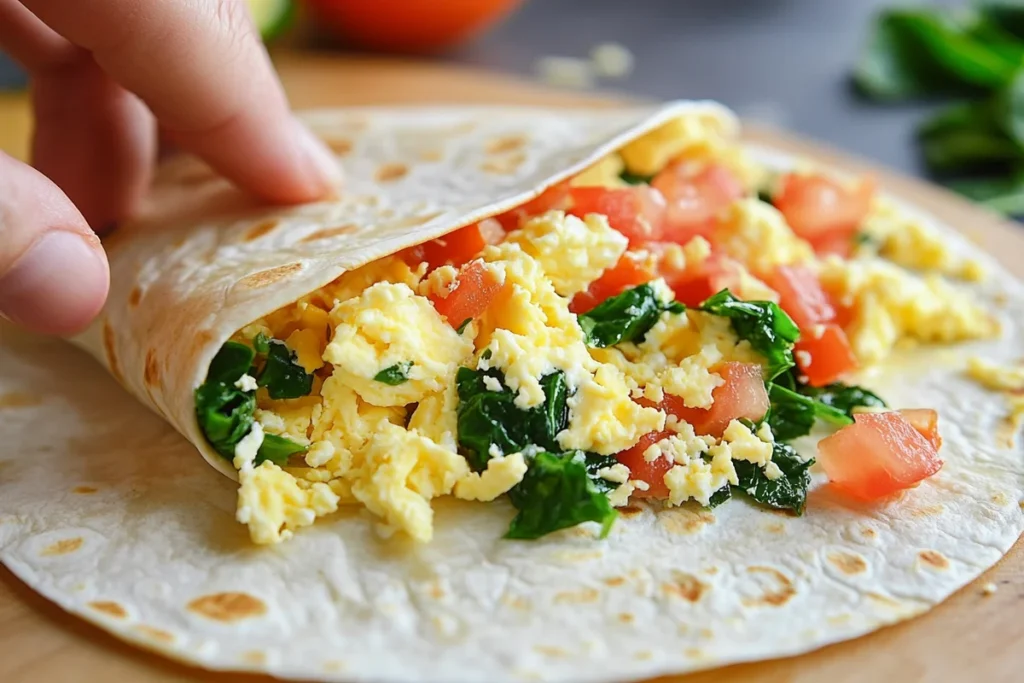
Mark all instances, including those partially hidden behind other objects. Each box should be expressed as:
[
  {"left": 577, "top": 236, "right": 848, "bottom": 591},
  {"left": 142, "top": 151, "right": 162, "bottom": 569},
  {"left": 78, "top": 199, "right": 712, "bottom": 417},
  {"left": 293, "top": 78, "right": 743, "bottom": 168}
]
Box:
[{"left": 854, "top": 0, "right": 1024, "bottom": 216}]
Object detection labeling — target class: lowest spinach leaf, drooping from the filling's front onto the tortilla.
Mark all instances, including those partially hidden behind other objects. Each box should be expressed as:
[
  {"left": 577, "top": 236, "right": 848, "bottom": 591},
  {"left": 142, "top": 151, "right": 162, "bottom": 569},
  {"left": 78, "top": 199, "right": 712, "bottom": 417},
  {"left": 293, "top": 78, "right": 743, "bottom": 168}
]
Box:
[{"left": 505, "top": 451, "right": 617, "bottom": 540}]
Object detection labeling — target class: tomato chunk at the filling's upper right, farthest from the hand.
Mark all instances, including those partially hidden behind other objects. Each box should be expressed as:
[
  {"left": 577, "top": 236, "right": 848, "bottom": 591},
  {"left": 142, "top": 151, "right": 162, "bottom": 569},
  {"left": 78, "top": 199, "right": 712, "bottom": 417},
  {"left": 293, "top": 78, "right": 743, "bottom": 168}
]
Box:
[{"left": 772, "top": 173, "right": 874, "bottom": 248}]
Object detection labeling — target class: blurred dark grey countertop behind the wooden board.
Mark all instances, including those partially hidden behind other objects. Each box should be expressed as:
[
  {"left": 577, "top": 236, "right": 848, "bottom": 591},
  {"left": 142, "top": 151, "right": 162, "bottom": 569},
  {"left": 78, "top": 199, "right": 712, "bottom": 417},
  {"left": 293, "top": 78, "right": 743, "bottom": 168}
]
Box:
[{"left": 0, "top": 0, "right": 950, "bottom": 179}]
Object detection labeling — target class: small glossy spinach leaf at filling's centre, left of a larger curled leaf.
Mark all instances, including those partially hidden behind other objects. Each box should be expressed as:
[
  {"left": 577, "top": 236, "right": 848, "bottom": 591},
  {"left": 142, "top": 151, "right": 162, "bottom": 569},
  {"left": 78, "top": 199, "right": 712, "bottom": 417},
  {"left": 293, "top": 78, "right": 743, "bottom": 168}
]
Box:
[{"left": 578, "top": 285, "right": 684, "bottom": 348}]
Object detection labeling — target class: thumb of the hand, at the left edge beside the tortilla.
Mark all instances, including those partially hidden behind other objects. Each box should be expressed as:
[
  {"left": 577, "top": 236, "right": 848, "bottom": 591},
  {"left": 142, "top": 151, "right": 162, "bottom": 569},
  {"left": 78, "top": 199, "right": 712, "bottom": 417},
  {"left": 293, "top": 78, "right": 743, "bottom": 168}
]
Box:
[{"left": 0, "top": 153, "right": 110, "bottom": 334}]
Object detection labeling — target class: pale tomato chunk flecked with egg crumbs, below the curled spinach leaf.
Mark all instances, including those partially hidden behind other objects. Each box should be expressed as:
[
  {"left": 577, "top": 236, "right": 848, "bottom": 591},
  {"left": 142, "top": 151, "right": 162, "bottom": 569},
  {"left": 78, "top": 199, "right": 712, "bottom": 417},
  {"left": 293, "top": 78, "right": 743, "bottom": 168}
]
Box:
[{"left": 662, "top": 362, "right": 769, "bottom": 436}]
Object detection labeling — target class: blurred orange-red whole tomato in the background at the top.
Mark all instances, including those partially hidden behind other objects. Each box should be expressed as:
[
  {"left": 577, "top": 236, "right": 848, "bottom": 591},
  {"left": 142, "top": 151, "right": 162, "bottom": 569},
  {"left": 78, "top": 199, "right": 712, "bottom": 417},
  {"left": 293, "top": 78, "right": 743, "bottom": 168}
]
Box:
[{"left": 306, "top": 0, "right": 522, "bottom": 52}]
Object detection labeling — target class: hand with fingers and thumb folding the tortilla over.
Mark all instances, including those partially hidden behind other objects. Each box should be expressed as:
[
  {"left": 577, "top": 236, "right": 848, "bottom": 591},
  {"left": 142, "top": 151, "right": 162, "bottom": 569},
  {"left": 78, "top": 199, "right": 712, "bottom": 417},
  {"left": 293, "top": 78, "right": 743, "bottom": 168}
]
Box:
[{"left": 0, "top": 0, "right": 338, "bottom": 334}]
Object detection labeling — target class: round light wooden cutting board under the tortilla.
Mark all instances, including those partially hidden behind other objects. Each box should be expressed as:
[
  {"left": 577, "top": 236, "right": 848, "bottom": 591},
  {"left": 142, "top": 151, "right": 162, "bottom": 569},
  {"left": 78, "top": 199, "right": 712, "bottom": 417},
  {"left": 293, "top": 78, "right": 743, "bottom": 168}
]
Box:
[{"left": 0, "top": 53, "right": 1024, "bottom": 683}]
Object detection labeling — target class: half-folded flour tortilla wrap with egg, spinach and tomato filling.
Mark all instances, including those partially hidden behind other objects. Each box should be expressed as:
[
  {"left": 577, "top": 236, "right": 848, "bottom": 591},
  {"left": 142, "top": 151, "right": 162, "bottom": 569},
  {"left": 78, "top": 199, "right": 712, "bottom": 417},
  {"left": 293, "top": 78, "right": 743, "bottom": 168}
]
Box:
[{"left": 0, "top": 102, "right": 1024, "bottom": 681}]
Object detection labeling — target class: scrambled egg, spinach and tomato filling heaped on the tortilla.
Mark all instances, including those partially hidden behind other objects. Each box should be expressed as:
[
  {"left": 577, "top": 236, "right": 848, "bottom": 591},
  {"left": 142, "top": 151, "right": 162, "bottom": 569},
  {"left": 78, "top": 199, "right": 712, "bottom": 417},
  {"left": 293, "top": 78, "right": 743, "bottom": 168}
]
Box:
[{"left": 196, "top": 116, "right": 998, "bottom": 544}]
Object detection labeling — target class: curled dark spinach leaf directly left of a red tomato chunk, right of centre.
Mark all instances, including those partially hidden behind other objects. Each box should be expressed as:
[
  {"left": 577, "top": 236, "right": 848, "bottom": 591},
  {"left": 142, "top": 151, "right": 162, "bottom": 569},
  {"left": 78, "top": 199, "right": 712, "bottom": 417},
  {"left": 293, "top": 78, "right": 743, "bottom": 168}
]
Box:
[{"left": 700, "top": 290, "right": 800, "bottom": 381}]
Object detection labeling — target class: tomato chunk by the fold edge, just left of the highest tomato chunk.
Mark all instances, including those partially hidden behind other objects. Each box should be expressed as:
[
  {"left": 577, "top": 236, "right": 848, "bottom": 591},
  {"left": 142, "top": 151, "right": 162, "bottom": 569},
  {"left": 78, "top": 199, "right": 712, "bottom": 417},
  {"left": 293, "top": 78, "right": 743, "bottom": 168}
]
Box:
[{"left": 569, "top": 185, "right": 665, "bottom": 246}]
